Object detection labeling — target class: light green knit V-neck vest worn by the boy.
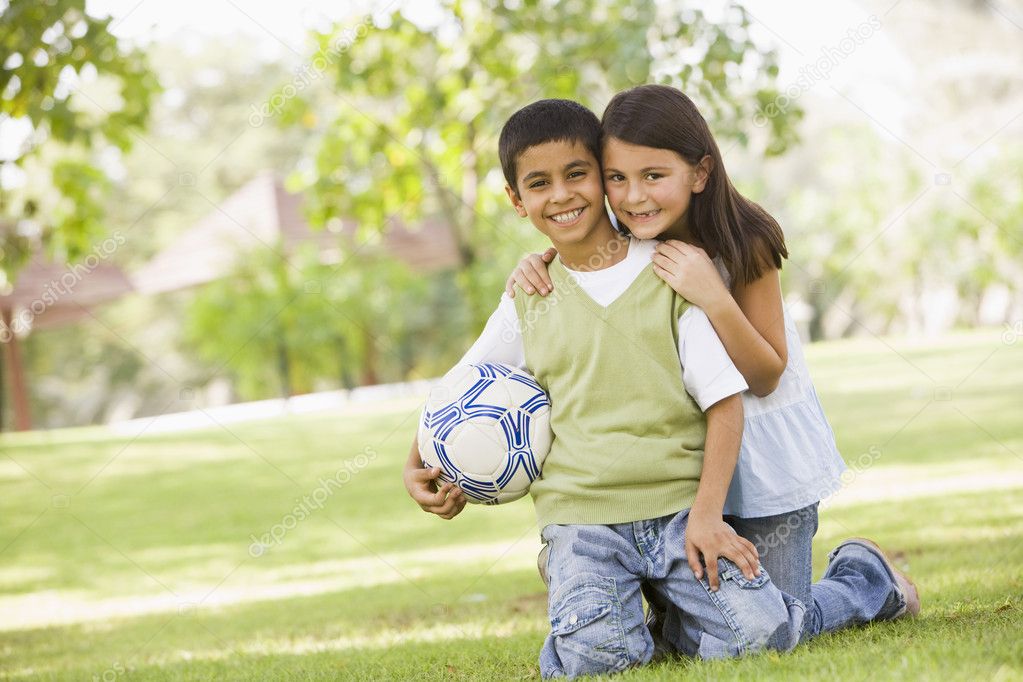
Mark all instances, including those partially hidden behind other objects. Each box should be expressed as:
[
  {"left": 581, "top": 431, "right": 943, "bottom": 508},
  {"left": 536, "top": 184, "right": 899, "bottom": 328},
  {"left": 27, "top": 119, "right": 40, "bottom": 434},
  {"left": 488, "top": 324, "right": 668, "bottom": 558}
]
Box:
[{"left": 515, "top": 250, "right": 707, "bottom": 530}]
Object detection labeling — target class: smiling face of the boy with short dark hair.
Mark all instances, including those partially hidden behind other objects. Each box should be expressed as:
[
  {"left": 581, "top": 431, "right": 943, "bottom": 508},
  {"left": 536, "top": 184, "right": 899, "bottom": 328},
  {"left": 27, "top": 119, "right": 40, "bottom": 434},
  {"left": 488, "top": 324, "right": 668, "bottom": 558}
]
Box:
[{"left": 504, "top": 141, "right": 610, "bottom": 246}]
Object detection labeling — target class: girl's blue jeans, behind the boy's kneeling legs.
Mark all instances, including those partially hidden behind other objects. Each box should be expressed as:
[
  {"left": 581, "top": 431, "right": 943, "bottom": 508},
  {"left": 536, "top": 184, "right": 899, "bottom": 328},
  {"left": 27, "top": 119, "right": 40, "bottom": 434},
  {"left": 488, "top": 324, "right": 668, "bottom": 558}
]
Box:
[{"left": 725, "top": 503, "right": 905, "bottom": 641}]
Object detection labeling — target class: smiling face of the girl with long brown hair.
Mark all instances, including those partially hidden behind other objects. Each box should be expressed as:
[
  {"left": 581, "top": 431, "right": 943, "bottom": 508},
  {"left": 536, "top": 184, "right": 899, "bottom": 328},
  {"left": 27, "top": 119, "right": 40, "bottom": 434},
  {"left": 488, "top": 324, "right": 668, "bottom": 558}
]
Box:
[{"left": 604, "top": 137, "right": 710, "bottom": 241}]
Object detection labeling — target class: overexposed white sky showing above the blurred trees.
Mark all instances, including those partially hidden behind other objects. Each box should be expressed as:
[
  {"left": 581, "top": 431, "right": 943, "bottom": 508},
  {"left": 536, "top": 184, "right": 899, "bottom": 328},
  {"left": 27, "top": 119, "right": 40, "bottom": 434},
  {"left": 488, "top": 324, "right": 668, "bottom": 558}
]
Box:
[{"left": 87, "top": 0, "right": 914, "bottom": 125}]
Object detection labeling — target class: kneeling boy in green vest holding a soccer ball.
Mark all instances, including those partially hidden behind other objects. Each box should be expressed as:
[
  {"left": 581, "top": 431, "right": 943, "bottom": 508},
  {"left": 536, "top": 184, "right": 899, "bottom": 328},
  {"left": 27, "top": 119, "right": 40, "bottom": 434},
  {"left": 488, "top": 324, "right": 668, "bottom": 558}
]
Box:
[{"left": 405, "top": 100, "right": 804, "bottom": 678}]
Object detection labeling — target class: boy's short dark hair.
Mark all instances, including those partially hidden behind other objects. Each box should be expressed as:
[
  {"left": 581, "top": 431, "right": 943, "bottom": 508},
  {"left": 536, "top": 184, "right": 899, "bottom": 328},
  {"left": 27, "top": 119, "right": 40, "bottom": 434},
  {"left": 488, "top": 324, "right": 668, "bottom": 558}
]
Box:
[{"left": 497, "top": 99, "right": 601, "bottom": 194}]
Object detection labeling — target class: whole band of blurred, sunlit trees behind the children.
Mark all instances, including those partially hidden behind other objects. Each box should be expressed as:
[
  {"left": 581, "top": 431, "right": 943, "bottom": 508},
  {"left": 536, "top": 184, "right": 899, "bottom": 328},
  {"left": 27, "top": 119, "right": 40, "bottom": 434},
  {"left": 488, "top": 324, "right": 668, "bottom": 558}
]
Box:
[{"left": 0, "top": 0, "right": 1023, "bottom": 425}]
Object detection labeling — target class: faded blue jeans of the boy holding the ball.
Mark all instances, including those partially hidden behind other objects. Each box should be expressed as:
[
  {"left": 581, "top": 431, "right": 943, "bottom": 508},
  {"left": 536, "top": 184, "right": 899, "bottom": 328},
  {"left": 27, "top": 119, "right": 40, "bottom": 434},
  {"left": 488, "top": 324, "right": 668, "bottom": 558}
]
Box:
[{"left": 540, "top": 509, "right": 804, "bottom": 678}]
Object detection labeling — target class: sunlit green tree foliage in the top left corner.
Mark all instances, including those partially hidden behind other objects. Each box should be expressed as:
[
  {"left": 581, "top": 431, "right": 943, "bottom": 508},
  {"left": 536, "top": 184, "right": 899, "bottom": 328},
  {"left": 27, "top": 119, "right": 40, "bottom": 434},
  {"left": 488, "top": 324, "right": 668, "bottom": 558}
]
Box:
[{"left": 0, "top": 0, "right": 159, "bottom": 280}]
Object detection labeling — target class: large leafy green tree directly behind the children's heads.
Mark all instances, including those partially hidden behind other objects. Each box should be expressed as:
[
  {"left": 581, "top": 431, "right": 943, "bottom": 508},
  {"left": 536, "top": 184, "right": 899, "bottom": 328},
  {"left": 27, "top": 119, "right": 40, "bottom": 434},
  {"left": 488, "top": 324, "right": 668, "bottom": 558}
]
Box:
[{"left": 282, "top": 0, "right": 800, "bottom": 331}]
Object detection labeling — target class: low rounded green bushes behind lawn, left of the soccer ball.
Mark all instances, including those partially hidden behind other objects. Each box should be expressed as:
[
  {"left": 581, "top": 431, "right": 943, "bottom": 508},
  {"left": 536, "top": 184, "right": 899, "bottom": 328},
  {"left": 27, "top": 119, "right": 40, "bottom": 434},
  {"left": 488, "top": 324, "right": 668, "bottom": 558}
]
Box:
[{"left": 185, "top": 244, "right": 432, "bottom": 399}]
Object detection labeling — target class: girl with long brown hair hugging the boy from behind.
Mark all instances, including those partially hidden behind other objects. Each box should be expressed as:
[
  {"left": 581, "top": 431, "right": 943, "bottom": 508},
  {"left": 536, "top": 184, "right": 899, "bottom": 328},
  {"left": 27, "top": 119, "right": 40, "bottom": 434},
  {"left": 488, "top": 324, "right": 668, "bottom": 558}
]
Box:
[{"left": 506, "top": 85, "right": 845, "bottom": 605}]
